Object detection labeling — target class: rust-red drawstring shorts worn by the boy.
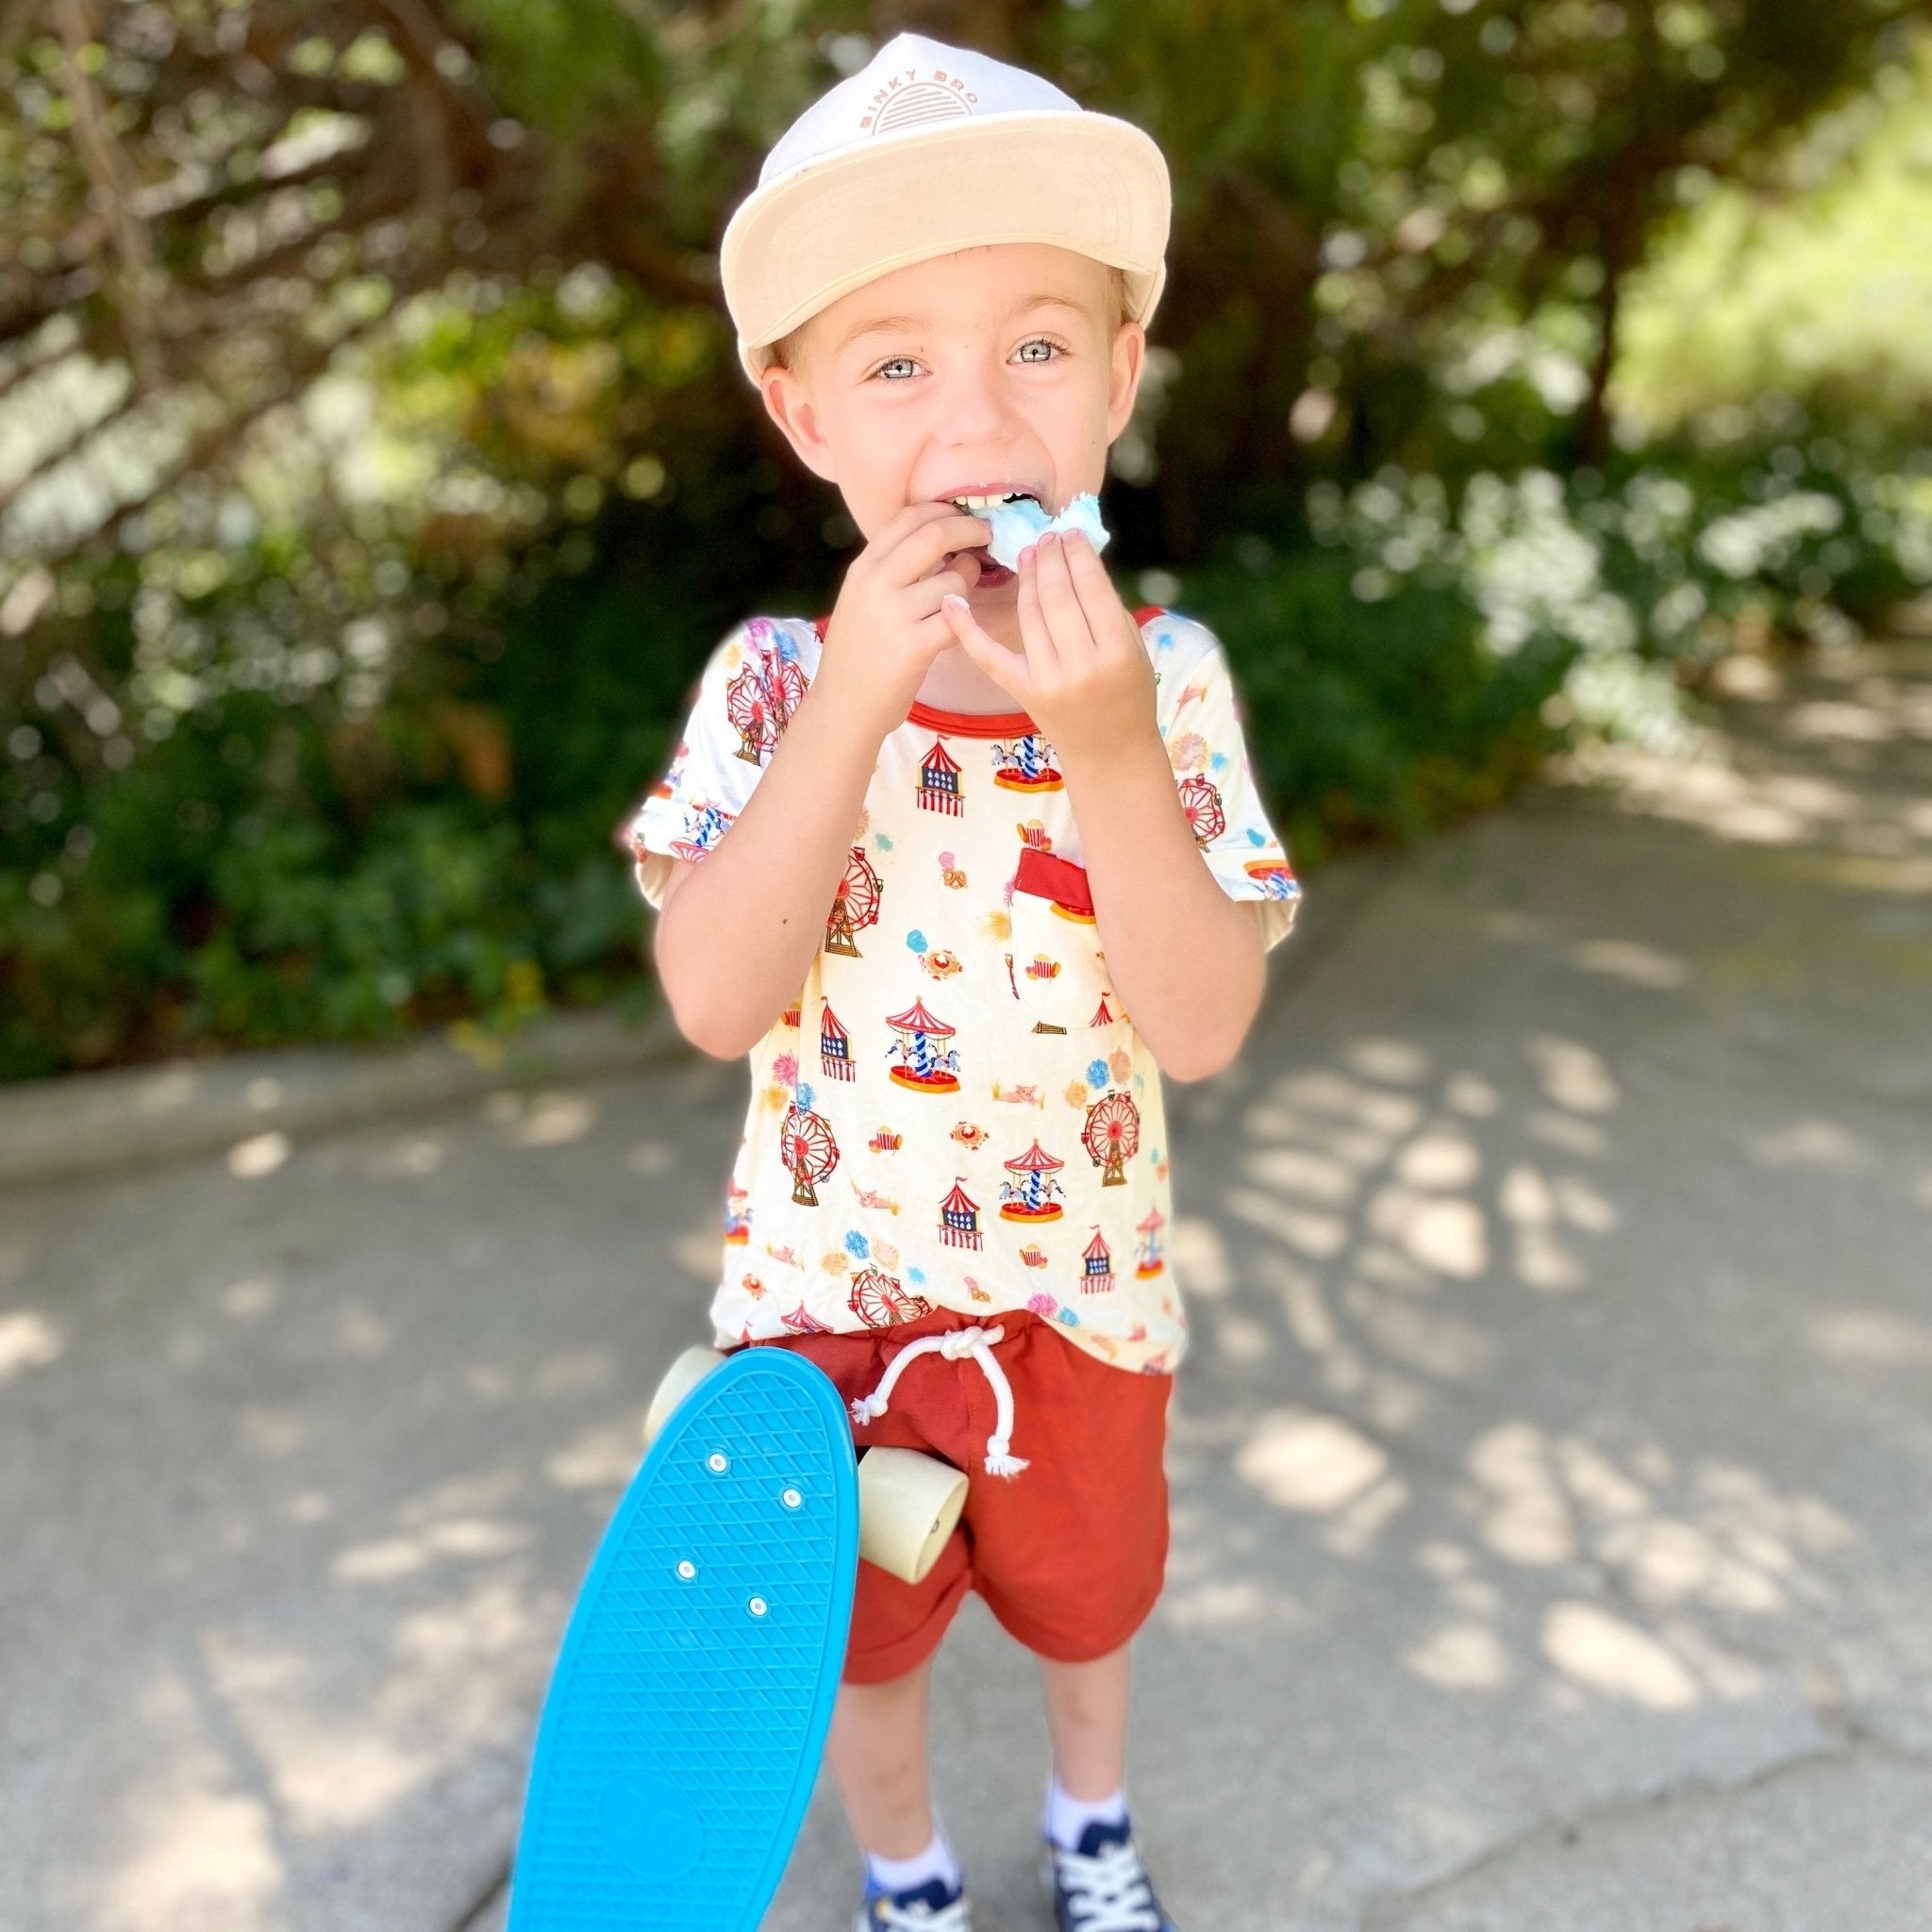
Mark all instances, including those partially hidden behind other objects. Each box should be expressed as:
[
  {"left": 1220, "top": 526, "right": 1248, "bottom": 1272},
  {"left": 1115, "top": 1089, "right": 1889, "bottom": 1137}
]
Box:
[{"left": 730, "top": 1307, "right": 1174, "bottom": 1685}]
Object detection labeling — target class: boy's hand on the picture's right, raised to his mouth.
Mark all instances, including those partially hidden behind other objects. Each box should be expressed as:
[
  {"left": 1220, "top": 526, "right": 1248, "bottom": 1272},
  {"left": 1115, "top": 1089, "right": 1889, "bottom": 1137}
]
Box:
[{"left": 939, "top": 529, "right": 1159, "bottom": 763}]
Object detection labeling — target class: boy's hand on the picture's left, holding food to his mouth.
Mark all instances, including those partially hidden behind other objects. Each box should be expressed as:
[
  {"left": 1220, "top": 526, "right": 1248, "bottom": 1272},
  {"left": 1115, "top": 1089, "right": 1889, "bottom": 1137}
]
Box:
[{"left": 813, "top": 502, "right": 993, "bottom": 740}]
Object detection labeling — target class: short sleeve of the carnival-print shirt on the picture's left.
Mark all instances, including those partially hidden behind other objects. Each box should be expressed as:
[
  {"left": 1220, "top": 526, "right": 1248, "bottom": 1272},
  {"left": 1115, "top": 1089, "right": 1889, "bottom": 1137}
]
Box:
[{"left": 625, "top": 616, "right": 811, "bottom": 908}]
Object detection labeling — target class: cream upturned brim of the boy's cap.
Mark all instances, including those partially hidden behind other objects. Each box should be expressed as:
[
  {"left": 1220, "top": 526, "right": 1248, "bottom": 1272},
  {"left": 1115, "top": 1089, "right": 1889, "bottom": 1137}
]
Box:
[{"left": 719, "top": 110, "right": 1169, "bottom": 383}]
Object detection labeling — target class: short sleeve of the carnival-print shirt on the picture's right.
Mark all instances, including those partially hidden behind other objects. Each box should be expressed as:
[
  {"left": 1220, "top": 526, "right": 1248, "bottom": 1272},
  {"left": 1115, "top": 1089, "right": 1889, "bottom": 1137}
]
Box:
[{"left": 1148, "top": 612, "right": 1302, "bottom": 951}]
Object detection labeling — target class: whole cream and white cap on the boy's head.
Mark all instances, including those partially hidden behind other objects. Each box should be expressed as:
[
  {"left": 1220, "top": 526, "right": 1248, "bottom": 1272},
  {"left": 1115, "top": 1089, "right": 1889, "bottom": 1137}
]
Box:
[{"left": 719, "top": 33, "right": 1171, "bottom": 383}]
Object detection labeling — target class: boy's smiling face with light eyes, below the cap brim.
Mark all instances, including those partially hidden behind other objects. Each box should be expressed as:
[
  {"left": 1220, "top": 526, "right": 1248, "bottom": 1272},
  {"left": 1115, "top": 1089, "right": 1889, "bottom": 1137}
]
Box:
[{"left": 761, "top": 242, "right": 1145, "bottom": 625}]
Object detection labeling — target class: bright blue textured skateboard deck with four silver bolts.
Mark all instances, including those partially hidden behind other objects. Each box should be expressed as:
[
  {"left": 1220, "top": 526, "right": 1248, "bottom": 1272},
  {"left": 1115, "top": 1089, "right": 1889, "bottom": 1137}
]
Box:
[{"left": 508, "top": 1349, "right": 858, "bottom": 1932}]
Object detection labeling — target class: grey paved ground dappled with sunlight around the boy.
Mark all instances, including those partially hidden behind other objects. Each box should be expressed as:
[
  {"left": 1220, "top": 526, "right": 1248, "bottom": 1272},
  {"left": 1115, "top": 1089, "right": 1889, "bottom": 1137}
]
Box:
[{"left": 11, "top": 647, "right": 1932, "bottom": 1932}]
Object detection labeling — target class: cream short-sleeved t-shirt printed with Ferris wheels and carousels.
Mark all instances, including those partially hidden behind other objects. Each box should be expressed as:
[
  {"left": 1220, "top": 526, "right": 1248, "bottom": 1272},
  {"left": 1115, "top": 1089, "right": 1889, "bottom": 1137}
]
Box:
[{"left": 630, "top": 608, "right": 1300, "bottom": 1374}]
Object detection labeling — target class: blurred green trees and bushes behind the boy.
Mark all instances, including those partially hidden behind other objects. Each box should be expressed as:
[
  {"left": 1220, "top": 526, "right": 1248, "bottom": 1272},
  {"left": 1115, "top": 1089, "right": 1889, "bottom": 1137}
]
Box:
[{"left": 0, "top": 0, "right": 1932, "bottom": 1078}]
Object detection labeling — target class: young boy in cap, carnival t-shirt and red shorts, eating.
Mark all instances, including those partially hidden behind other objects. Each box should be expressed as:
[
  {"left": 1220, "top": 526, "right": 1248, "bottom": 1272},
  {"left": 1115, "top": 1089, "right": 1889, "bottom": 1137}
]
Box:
[{"left": 632, "top": 35, "right": 1300, "bottom": 1932}]
